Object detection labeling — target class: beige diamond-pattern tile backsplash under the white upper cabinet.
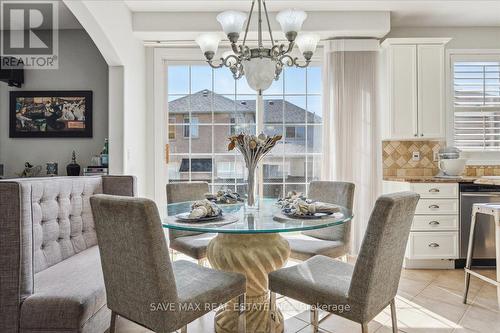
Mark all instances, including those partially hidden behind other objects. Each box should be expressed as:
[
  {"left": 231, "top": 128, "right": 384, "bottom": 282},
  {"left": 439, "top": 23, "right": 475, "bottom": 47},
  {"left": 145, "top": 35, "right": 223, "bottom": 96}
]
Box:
[{"left": 382, "top": 141, "right": 445, "bottom": 177}]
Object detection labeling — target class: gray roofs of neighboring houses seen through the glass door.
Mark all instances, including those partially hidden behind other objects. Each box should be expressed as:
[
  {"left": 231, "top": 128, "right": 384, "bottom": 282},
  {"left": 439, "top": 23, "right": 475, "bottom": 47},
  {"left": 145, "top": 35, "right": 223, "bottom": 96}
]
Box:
[{"left": 168, "top": 90, "right": 321, "bottom": 123}]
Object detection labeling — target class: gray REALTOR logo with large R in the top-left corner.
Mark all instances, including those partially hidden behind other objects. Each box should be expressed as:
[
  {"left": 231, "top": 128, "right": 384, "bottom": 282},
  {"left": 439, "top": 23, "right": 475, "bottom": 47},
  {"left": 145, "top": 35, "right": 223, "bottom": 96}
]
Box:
[{"left": 0, "top": 1, "right": 58, "bottom": 69}]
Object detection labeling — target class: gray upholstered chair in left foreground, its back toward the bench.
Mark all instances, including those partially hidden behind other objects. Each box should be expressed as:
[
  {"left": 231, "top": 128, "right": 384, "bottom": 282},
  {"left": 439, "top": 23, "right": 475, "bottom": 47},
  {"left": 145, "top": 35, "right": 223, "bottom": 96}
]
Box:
[{"left": 90, "top": 195, "right": 246, "bottom": 333}]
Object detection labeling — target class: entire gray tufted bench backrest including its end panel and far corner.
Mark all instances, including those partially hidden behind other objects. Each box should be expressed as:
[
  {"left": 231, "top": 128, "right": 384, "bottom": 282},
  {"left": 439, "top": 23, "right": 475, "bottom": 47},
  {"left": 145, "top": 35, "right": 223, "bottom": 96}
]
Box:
[{"left": 0, "top": 176, "right": 136, "bottom": 332}]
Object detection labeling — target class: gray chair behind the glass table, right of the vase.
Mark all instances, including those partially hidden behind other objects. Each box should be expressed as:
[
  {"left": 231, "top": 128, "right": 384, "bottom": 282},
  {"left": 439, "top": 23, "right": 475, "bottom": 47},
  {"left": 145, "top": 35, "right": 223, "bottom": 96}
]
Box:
[{"left": 287, "top": 181, "right": 354, "bottom": 261}]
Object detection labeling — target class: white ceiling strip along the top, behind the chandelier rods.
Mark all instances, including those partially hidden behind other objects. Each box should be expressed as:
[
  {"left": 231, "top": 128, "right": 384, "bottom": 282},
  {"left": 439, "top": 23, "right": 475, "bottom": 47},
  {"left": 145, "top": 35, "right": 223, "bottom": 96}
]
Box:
[{"left": 125, "top": 0, "right": 500, "bottom": 27}]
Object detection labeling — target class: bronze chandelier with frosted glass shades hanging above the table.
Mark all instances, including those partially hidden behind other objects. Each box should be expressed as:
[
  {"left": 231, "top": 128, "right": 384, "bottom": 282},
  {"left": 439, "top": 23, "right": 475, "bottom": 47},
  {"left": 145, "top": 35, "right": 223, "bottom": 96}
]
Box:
[{"left": 196, "top": 0, "right": 319, "bottom": 92}]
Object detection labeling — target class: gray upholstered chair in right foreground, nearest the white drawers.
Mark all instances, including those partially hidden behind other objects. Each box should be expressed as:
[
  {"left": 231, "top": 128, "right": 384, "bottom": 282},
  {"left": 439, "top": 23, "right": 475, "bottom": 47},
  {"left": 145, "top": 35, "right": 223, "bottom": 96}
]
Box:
[{"left": 269, "top": 192, "right": 419, "bottom": 333}]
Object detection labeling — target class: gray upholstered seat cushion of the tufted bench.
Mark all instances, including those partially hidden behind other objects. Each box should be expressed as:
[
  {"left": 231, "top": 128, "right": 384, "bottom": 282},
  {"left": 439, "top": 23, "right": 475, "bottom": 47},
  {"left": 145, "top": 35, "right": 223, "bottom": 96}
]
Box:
[{"left": 20, "top": 246, "right": 107, "bottom": 331}]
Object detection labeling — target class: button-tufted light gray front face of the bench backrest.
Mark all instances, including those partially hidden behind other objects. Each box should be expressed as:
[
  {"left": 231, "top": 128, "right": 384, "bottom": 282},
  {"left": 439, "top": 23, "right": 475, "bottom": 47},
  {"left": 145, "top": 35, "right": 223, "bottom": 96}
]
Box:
[{"left": 29, "top": 177, "right": 102, "bottom": 273}]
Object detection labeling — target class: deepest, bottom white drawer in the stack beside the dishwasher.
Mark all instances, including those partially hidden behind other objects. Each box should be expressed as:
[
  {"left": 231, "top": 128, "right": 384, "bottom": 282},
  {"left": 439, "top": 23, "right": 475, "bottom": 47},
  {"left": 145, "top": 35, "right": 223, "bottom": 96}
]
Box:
[{"left": 407, "top": 231, "right": 458, "bottom": 259}]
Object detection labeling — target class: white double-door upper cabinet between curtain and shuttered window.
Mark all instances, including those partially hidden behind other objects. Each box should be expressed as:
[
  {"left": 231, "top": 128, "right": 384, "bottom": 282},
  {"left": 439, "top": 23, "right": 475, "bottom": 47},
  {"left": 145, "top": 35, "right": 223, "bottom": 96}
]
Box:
[{"left": 382, "top": 38, "right": 449, "bottom": 140}]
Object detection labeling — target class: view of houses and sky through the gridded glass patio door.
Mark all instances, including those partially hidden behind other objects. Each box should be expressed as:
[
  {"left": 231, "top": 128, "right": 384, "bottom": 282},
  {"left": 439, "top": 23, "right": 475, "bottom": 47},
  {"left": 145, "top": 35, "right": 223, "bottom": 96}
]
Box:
[{"left": 168, "top": 65, "right": 323, "bottom": 197}]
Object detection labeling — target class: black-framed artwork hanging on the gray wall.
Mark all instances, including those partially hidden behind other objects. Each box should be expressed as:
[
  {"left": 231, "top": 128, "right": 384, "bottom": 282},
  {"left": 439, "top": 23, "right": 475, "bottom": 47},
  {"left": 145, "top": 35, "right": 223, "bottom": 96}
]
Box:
[{"left": 9, "top": 90, "right": 92, "bottom": 138}]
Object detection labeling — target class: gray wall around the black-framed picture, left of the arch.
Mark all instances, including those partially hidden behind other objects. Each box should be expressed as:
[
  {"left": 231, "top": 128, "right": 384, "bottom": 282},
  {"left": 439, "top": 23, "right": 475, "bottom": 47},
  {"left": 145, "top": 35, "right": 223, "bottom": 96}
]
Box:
[{"left": 0, "top": 30, "right": 108, "bottom": 176}]
